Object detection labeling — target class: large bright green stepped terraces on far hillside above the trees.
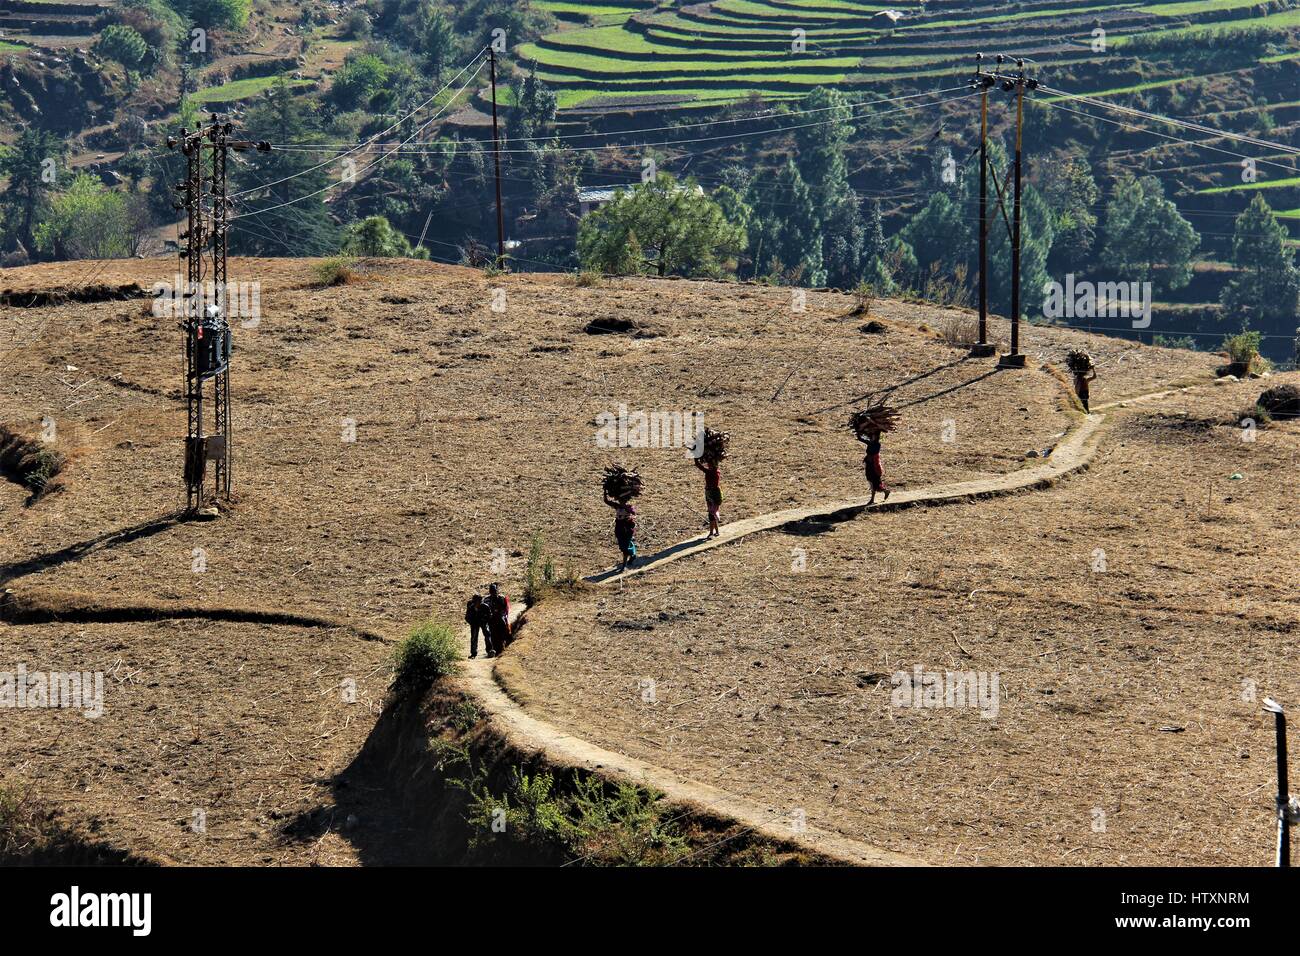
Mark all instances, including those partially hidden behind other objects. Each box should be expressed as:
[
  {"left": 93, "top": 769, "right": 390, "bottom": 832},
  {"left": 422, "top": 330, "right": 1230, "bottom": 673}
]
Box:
[{"left": 515, "top": 0, "right": 1300, "bottom": 109}]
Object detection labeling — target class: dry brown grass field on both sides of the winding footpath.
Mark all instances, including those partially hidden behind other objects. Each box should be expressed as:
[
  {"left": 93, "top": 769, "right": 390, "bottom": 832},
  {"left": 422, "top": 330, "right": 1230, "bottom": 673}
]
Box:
[{"left": 0, "top": 260, "right": 1300, "bottom": 864}]
